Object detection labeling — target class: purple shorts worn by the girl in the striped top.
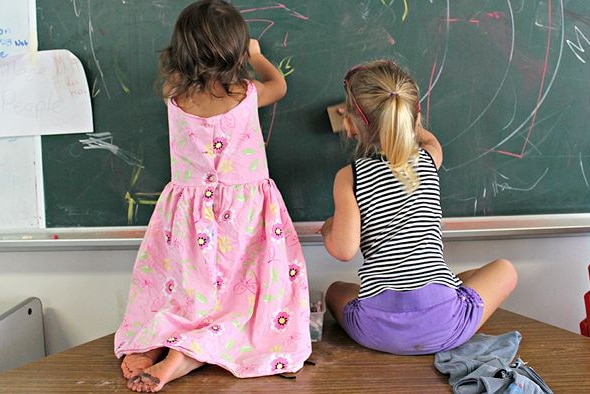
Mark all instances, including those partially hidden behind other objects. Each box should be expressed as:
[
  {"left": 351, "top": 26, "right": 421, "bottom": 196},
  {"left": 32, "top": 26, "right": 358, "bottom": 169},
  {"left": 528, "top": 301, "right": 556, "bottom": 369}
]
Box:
[{"left": 343, "top": 283, "right": 483, "bottom": 355}]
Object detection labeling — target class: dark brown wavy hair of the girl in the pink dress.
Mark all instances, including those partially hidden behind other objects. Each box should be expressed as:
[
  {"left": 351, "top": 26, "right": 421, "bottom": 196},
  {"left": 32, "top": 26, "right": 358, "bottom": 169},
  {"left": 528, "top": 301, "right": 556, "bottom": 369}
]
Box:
[{"left": 160, "top": 0, "right": 250, "bottom": 97}]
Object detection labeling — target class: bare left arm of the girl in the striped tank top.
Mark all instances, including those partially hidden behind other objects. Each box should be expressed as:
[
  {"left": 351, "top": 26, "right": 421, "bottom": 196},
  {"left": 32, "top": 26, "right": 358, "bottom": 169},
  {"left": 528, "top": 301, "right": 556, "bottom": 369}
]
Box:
[{"left": 321, "top": 165, "right": 361, "bottom": 261}]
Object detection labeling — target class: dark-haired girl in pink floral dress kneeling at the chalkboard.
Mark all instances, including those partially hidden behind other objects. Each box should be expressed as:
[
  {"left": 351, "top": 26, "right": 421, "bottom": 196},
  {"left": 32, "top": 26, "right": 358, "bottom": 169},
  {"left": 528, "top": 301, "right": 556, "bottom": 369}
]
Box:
[{"left": 115, "top": 0, "right": 311, "bottom": 392}]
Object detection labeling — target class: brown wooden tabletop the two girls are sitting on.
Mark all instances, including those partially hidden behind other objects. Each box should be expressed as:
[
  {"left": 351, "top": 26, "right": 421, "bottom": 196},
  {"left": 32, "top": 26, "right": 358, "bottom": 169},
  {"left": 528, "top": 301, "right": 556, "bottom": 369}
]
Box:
[{"left": 0, "top": 310, "right": 590, "bottom": 394}]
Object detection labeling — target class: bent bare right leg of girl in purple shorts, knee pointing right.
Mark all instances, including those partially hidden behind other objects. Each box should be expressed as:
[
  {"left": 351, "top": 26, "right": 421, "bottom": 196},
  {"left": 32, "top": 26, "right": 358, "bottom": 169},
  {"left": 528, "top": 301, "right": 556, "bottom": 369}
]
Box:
[{"left": 458, "top": 259, "right": 518, "bottom": 329}]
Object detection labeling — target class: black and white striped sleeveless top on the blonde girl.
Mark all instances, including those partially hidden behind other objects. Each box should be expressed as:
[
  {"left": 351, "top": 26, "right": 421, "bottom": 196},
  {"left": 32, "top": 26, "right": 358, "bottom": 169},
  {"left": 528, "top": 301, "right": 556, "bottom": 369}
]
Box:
[{"left": 352, "top": 149, "right": 462, "bottom": 298}]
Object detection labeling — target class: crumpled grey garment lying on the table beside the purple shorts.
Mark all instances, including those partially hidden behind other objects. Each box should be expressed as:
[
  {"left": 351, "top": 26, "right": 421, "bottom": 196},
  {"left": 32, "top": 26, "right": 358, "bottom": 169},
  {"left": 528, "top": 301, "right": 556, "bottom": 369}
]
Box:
[{"left": 434, "top": 331, "right": 553, "bottom": 394}]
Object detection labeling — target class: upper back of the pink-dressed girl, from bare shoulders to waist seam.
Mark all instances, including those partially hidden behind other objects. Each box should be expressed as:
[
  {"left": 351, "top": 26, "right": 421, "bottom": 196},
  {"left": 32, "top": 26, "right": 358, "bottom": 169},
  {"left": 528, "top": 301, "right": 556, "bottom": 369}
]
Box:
[{"left": 168, "top": 83, "right": 268, "bottom": 188}]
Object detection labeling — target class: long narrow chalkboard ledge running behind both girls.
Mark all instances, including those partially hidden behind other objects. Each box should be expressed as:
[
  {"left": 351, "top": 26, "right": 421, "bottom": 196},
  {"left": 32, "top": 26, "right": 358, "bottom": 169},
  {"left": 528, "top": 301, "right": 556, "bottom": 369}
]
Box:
[{"left": 0, "top": 214, "right": 590, "bottom": 253}]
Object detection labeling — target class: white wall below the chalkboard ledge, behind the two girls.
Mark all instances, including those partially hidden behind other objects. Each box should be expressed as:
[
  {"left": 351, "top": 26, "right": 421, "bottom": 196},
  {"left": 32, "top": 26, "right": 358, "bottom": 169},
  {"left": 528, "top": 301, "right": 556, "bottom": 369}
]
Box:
[{"left": 0, "top": 234, "right": 590, "bottom": 354}]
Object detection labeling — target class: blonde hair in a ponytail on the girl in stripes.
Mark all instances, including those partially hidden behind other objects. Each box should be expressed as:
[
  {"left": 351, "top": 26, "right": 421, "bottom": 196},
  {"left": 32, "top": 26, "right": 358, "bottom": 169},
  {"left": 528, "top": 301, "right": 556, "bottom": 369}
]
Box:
[{"left": 344, "top": 60, "right": 420, "bottom": 193}]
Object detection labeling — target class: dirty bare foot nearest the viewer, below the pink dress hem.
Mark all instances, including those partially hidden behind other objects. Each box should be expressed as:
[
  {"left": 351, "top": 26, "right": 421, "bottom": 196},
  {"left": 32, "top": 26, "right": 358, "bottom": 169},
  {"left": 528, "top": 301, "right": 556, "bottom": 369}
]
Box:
[{"left": 127, "top": 349, "right": 204, "bottom": 393}]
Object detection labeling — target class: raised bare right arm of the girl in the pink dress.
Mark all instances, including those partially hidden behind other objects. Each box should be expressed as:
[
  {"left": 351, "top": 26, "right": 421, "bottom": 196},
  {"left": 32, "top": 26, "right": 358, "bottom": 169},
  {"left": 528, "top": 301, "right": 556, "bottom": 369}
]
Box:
[{"left": 248, "top": 39, "right": 287, "bottom": 107}]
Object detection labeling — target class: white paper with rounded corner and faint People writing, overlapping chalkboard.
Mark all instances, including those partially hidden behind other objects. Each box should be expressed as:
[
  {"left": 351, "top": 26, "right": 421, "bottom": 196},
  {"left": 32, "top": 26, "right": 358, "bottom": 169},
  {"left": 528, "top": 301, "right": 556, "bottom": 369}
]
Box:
[{"left": 0, "top": 49, "right": 93, "bottom": 137}]
